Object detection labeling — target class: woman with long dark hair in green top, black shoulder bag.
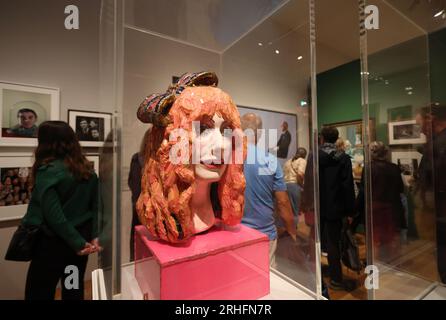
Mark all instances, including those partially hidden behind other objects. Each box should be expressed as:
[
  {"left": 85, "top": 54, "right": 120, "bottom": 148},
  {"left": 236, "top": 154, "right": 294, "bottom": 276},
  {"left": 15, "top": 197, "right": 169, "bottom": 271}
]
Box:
[{"left": 22, "top": 121, "right": 101, "bottom": 300}]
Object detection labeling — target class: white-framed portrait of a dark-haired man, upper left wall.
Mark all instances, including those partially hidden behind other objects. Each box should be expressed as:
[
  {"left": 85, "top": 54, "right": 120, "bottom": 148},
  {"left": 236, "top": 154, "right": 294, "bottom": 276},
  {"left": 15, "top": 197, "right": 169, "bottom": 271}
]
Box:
[{"left": 0, "top": 82, "right": 59, "bottom": 147}]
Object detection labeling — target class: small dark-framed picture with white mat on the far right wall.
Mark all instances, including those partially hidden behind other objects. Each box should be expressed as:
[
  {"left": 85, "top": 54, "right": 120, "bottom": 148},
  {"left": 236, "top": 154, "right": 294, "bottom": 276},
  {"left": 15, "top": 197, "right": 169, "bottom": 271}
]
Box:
[{"left": 389, "top": 120, "right": 426, "bottom": 145}]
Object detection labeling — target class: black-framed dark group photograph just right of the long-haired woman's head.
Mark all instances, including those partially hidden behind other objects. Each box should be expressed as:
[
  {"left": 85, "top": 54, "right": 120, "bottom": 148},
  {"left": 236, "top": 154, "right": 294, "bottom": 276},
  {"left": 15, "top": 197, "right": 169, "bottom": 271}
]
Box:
[{"left": 68, "top": 110, "right": 112, "bottom": 147}]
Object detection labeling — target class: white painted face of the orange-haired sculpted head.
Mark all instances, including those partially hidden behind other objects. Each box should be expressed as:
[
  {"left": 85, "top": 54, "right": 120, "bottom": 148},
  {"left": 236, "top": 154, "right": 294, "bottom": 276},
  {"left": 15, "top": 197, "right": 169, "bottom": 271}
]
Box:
[{"left": 194, "top": 114, "right": 231, "bottom": 182}]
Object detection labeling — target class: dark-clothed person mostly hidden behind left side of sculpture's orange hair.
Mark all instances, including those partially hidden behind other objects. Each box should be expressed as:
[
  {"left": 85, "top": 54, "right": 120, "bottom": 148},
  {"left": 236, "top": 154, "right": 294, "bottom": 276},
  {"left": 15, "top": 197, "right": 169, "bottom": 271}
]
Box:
[{"left": 127, "top": 128, "right": 151, "bottom": 261}]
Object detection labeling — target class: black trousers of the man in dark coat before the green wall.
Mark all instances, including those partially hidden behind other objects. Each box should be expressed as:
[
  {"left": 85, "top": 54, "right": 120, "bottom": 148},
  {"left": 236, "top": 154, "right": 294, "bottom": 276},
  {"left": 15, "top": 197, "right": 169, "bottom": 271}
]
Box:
[{"left": 321, "top": 217, "right": 343, "bottom": 282}]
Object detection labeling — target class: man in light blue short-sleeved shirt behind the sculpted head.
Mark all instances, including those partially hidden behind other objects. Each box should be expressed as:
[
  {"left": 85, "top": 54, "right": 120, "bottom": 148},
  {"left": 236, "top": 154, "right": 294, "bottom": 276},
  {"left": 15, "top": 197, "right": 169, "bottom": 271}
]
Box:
[{"left": 241, "top": 113, "right": 297, "bottom": 266}]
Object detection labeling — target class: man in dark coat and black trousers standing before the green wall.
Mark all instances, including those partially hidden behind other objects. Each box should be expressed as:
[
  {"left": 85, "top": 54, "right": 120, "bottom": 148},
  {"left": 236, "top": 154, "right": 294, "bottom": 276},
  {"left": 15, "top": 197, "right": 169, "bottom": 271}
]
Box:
[{"left": 301, "top": 127, "right": 355, "bottom": 291}]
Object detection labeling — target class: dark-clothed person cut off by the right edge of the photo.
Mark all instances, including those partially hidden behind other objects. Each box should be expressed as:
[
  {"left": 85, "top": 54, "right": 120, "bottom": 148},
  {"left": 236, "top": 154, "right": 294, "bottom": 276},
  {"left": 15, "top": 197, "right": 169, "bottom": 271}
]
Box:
[{"left": 417, "top": 103, "right": 446, "bottom": 283}]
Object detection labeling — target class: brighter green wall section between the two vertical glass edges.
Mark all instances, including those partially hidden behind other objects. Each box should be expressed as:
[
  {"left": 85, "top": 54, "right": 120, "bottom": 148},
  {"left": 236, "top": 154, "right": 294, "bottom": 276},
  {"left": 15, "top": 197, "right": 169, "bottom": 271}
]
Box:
[{"left": 317, "top": 60, "right": 362, "bottom": 127}]
